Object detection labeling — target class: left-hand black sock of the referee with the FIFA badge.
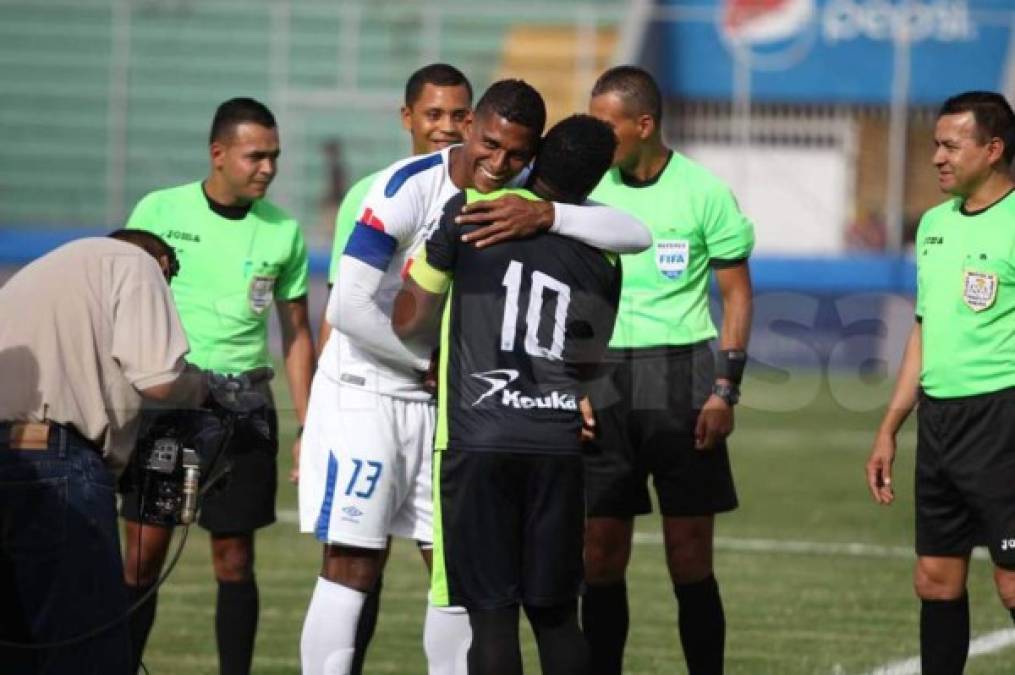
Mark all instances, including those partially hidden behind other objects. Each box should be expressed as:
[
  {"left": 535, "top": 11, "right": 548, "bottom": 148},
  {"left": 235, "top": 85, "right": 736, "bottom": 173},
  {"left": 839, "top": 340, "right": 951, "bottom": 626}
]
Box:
[{"left": 582, "top": 580, "right": 630, "bottom": 675}]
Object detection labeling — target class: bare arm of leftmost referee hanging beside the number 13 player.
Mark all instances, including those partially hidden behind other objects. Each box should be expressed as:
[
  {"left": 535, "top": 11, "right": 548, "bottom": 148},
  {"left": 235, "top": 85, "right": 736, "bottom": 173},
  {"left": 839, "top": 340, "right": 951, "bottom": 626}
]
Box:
[{"left": 276, "top": 295, "right": 315, "bottom": 482}]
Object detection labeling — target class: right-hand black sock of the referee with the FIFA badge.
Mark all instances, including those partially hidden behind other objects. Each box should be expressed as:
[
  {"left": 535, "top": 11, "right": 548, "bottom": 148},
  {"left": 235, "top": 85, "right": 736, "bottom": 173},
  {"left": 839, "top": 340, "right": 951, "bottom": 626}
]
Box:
[{"left": 673, "top": 575, "right": 726, "bottom": 675}]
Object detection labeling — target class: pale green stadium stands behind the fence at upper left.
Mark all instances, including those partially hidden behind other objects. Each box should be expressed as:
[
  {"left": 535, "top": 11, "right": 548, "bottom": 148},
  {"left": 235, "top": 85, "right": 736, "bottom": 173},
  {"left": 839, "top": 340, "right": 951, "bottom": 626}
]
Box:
[{"left": 0, "top": 0, "right": 624, "bottom": 236}]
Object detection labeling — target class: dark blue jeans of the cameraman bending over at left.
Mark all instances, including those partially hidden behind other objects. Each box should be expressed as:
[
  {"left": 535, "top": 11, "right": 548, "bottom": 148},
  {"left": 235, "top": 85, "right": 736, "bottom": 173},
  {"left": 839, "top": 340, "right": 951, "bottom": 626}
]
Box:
[{"left": 0, "top": 422, "right": 130, "bottom": 675}]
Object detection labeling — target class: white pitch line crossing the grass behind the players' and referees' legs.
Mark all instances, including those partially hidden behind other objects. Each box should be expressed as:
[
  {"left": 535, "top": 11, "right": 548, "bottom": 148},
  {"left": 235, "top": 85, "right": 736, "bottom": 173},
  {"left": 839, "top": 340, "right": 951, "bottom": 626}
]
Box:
[{"left": 278, "top": 509, "right": 988, "bottom": 559}]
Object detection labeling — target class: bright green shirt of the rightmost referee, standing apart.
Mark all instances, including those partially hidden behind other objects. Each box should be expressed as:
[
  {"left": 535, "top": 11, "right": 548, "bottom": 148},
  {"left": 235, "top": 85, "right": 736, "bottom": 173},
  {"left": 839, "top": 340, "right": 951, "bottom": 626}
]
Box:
[{"left": 916, "top": 192, "right": 1015, "bottom": 398}]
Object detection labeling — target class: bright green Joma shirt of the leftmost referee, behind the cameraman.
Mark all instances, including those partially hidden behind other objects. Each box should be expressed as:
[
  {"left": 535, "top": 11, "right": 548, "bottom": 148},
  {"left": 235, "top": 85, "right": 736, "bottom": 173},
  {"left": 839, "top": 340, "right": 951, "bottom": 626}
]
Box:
[{"left": 127, "top": 183, "right": 308, "bottom": 374}]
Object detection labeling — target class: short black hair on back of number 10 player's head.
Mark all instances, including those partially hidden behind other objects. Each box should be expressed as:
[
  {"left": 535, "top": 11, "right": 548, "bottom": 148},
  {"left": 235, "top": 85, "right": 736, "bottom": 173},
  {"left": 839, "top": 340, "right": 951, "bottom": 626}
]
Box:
[{"left": 529, "top": 115, "right": 617, "bottom": 204}]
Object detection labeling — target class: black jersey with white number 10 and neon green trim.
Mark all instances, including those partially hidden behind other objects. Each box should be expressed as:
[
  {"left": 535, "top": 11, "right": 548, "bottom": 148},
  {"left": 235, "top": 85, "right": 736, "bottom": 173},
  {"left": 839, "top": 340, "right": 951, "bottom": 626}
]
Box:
[{"left": 410, "top": 186, "right": 620, "bottom": 453}]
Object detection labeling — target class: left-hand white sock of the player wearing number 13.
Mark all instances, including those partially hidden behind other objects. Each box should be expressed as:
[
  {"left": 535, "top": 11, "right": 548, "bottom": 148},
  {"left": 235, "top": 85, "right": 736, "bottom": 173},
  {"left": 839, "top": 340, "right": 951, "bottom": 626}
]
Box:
[{"left": 299, "top": 577, "right": 366, "bottom": 675}]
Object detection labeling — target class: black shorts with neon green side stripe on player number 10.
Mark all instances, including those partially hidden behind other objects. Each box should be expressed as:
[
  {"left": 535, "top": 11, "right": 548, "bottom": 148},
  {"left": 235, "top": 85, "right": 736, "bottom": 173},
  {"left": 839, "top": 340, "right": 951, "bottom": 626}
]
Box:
[{"left": 430, "top": 450, "right": 585, "bottom": 610}]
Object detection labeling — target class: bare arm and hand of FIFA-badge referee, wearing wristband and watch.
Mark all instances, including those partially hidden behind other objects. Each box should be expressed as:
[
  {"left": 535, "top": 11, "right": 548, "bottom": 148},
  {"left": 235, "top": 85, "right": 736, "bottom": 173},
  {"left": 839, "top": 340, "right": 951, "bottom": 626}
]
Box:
[{"left": 694, "top": 260, "right": 754, "bottom": 450}]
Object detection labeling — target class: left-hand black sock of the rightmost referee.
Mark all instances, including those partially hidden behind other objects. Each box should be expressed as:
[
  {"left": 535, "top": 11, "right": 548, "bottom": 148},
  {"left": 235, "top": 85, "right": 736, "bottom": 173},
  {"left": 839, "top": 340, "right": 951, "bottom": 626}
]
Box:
[{"left": 920, "top": 594, "right": 969, "bottom": 675}]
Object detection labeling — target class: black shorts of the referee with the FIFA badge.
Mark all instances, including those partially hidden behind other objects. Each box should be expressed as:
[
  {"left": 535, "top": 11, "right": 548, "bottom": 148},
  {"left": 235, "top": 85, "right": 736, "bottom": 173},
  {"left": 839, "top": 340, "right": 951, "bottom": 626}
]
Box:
[{"left": 585, "top": 342, "right": 737, "bottom": 518}]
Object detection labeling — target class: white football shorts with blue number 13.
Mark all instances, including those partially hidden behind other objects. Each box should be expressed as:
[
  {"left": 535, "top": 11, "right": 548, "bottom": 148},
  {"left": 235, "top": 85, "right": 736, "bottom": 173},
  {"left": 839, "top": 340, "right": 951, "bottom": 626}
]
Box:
[{"left": 299, "top": 369, "right": 434, "bottom": 548}]
